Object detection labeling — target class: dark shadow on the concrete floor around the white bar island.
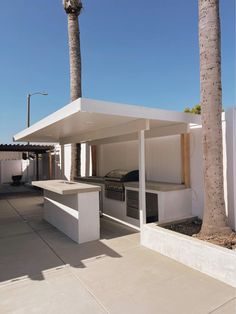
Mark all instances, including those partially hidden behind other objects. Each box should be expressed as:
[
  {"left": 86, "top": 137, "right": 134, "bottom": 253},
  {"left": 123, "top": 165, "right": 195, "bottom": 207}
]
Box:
[{"left": 0, "top": 194, "right": 138, "bottom": 283}]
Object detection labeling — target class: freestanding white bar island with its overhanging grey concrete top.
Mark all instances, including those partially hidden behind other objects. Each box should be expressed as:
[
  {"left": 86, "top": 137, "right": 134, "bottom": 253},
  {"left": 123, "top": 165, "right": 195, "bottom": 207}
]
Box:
[{"left": 32, "top": 180, "right": 101, "bottom": 243}]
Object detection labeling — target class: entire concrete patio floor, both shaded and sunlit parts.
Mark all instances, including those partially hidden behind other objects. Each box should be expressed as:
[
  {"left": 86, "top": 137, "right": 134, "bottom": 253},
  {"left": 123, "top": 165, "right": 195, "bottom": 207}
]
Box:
[{"left": 0, "top": 195, "right": 236, "bottom": 314}]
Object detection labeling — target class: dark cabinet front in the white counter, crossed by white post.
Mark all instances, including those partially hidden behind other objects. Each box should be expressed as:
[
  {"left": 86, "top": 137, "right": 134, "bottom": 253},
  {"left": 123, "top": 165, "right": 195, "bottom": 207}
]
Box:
[{"left": 126, "top": 190, "right": 158, "bottom": 223}]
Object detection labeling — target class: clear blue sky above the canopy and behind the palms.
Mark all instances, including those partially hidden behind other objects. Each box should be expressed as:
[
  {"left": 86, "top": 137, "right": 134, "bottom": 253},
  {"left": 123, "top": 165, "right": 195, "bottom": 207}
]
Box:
[{"left": 0, "top": 0, "right": 235, "bottom": 143}]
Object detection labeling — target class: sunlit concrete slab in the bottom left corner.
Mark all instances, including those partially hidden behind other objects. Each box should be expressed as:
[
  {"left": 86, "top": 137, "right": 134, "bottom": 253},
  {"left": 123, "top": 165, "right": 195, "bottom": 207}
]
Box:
[{"left": 0, "top": 268, "right": 107, "bottom": 314}]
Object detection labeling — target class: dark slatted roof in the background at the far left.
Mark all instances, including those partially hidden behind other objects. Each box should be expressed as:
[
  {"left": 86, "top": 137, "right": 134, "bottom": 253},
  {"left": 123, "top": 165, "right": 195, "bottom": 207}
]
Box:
[{"left": 0, "top": 144, "right": 54, "bottom": 154}]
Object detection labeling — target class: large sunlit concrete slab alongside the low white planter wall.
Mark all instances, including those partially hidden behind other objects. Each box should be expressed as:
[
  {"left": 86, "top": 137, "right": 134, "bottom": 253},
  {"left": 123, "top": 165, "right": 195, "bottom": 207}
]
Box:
[{"left": 72, "top": 247, "right": 236, "bottom": 314}]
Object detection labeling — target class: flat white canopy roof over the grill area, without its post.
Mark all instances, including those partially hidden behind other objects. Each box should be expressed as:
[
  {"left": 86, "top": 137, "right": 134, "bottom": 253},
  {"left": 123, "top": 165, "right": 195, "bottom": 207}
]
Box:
[{"left": 14, "top": 98, "right": 201, "bottom": 144}]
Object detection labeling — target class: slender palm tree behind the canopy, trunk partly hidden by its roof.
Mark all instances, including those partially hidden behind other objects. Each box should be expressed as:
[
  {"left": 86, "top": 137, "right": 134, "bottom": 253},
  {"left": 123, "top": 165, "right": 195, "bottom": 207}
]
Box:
[{"left": 63, "top": 0, "right": 82, "bottom": 180}]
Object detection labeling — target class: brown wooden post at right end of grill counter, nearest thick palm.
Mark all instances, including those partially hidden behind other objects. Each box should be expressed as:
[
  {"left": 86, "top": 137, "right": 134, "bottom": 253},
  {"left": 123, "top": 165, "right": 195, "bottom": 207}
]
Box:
[{"left": 181, "top": 133, "right": 191, "bottom": 188}]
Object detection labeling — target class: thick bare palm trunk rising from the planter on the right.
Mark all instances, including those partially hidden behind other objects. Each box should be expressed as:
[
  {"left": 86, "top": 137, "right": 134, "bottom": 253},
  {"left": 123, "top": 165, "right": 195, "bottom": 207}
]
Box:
[{"left": 198, "top": 0, "right": 230, "bottom": 236}]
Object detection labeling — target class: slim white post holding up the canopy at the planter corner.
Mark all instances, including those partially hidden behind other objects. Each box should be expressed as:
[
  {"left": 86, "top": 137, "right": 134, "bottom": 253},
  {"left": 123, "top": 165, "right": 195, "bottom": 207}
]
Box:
[{"left": 139, "top": 130, "right": 146, "bottom": 229}]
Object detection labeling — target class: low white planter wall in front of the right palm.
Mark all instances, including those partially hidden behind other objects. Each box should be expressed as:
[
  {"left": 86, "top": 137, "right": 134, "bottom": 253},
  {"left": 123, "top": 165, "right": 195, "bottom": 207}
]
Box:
[{"left": 141, "top": 224, "right": 236, "bottom": 287}]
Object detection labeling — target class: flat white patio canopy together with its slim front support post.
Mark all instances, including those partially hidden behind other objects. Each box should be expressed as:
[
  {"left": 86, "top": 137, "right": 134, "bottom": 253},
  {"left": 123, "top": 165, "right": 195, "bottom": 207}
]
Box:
[{"left": 14, "top": 98, "right": 201, "bottom": 228}]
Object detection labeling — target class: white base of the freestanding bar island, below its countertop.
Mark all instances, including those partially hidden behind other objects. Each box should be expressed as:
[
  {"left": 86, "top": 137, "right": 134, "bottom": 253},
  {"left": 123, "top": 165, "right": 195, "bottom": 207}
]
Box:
[{"left": 44, "top": 190, "right": 100, "bottom": 243}]
